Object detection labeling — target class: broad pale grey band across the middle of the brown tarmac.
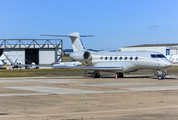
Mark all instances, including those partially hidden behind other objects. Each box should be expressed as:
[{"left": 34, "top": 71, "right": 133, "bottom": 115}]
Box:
[{"left": 3, "top": 86, "right": 178, "bottom": 96}]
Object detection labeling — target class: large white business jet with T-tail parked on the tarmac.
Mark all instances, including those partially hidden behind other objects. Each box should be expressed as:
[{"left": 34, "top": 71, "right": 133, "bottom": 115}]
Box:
[{"left": 31, "top": 32, "right": 172, "bottom": 79}]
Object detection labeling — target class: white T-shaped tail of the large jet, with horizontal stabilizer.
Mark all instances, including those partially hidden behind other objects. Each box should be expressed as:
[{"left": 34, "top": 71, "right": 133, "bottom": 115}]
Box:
[{"left": 40, "top": 32, "right": 93, "bottom": 52}]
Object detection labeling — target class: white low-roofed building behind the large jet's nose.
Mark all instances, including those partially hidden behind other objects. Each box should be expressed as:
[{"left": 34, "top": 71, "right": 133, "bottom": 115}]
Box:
[{"left": 119, "top": 43, "right": 178, "bottom": 55}]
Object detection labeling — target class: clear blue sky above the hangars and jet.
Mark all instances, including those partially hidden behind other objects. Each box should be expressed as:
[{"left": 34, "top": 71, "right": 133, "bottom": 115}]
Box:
[{"left": 0, "top": 0, "right": 178, "bottom": 50}]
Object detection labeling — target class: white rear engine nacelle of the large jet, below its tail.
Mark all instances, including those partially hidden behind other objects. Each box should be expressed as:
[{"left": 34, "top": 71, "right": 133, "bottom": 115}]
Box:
[{"left": 70, "top": 50, "right": 91, "bottom": 61}]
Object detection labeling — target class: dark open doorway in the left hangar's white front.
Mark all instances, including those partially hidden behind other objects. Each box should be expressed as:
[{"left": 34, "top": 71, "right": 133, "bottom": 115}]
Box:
[{"left": 25, "top": 49, "right": 39, "bottom": 64}]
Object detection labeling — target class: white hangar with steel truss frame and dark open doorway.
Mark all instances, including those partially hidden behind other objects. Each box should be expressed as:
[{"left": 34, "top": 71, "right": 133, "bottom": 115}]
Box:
[{"left": 0, "top": 39, "right": 62, "bottom": 64}]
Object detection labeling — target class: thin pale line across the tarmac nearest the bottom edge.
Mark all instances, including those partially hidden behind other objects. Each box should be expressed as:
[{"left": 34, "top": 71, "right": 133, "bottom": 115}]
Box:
[{"left": 0, "top": 106, "right": 178, "bottom": 118}]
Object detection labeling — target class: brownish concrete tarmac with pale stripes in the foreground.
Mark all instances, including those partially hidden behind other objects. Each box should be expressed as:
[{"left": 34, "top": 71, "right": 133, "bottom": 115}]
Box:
[{"left": 0, "top": 70, "right": 178, "bottom": 120}]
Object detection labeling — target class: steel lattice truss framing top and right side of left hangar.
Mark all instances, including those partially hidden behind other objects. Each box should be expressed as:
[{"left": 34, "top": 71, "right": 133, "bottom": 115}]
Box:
[{"left": 0, "top": 39, "right": 63, "bottom": 62}]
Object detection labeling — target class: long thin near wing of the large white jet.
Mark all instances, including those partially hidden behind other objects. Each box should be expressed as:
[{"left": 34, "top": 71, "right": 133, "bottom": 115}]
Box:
[{"left": 20, "top": 64, "right": 124, "bottom": 71}]
